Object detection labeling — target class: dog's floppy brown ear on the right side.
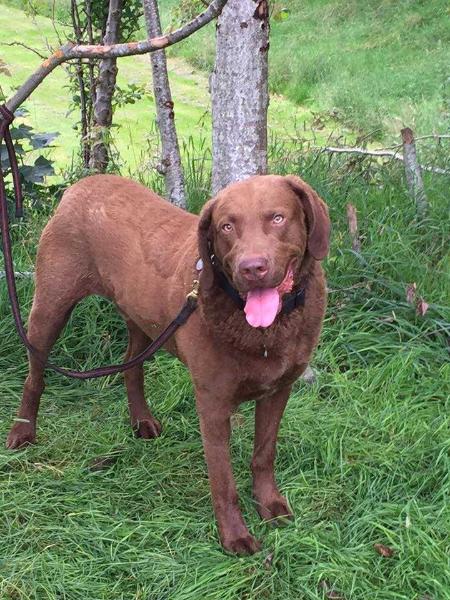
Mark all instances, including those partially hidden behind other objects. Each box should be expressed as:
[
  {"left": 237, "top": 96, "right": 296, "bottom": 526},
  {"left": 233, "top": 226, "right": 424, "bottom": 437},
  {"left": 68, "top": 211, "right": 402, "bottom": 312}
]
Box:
[{"left": 286, "top": 175, "right": 331, "bottom": 260}]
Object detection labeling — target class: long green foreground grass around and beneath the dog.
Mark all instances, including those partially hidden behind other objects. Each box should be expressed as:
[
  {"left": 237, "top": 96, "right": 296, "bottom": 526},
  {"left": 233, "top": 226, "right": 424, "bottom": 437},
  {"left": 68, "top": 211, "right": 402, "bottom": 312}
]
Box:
[{"left": 0, "top": 149, "right": 450, "bottom": 600}]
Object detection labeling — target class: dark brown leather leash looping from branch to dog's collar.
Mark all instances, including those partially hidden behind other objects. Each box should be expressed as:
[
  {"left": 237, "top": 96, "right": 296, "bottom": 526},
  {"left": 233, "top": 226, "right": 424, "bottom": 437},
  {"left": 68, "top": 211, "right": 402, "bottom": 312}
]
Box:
[{"left": 0, "top": 105, "right": 198, "bottom": 379}]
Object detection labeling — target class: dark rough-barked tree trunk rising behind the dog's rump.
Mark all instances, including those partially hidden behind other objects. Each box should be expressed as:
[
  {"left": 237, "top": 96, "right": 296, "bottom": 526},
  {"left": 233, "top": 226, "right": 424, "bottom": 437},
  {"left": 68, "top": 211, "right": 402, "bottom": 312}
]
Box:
[{"left": 90, "top": 0, "right": 122, "bottom": 172}]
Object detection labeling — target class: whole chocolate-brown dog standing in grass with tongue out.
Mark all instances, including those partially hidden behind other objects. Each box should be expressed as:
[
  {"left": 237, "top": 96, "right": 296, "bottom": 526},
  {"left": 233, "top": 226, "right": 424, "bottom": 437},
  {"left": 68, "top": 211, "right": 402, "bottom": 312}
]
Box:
[{"left": 7, "top": 175, "right": 330, "bottom": 553}]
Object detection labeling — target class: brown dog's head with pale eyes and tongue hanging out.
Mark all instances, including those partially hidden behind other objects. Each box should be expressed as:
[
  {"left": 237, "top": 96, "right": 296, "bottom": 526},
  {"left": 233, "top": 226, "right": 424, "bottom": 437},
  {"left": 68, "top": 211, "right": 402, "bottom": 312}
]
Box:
[{"left": 199, "top": 175, "right": 330, "bottom": 327}]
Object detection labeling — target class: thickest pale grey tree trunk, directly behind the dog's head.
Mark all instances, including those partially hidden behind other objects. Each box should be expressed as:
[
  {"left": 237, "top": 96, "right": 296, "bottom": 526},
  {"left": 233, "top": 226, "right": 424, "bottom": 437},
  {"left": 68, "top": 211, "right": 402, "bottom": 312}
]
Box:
[{"left": 211, "top": 0, "right": 269, "bottom": 194}]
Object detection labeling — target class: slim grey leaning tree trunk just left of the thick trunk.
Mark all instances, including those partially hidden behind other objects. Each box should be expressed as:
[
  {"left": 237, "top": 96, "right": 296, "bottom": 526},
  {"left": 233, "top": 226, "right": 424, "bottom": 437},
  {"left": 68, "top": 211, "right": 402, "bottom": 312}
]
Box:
[{"left": 142, "top": 0, "right": 186, "bottom": 208}]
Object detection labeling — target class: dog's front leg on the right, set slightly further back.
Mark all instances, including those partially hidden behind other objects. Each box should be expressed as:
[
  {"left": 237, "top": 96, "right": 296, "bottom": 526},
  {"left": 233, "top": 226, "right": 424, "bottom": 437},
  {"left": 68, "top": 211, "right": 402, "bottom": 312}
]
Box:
[{"left": 252, "top": 386, "right": 292, "bottom": 520}]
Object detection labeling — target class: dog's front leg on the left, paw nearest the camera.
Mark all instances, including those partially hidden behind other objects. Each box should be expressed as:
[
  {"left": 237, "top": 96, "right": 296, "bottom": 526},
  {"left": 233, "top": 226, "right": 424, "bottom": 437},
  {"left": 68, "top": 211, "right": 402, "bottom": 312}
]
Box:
[{"left": 196, "top": 391, "right": 261, "bottom": 554}]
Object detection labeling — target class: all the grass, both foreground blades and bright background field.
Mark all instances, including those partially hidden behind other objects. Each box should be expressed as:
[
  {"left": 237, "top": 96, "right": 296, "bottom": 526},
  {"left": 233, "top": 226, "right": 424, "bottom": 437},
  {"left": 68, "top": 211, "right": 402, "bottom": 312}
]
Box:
[{"left": 0, "top": 0, "right": 450, "bottom": 600}]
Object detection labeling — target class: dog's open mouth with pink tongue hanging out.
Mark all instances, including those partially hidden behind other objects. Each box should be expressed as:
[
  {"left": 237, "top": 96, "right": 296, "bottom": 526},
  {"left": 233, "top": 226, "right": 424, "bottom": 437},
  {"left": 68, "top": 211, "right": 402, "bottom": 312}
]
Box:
[{"left": 244, "top": 261, "right": 295, "bottom": 327}]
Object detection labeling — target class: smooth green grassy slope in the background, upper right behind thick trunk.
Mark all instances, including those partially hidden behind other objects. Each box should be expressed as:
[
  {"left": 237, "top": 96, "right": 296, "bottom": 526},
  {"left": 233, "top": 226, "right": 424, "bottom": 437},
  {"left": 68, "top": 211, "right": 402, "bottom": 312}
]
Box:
[{"left": 164, "top": 0, "right": 450, "bottom": 141}]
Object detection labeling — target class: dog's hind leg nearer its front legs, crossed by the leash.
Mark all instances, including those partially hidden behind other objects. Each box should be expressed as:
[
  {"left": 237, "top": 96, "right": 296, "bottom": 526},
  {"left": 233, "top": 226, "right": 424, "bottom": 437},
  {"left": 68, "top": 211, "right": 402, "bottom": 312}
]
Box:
[{"left": 124, "top": 319, "right": 161, "bottom": 439}]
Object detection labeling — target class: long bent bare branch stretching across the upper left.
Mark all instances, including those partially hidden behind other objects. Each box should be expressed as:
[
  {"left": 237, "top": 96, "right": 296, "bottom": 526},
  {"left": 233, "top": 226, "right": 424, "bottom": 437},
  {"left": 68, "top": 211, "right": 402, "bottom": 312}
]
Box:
[{"left": 0, "top": 0, "right": 227, "bottom": 117}]
